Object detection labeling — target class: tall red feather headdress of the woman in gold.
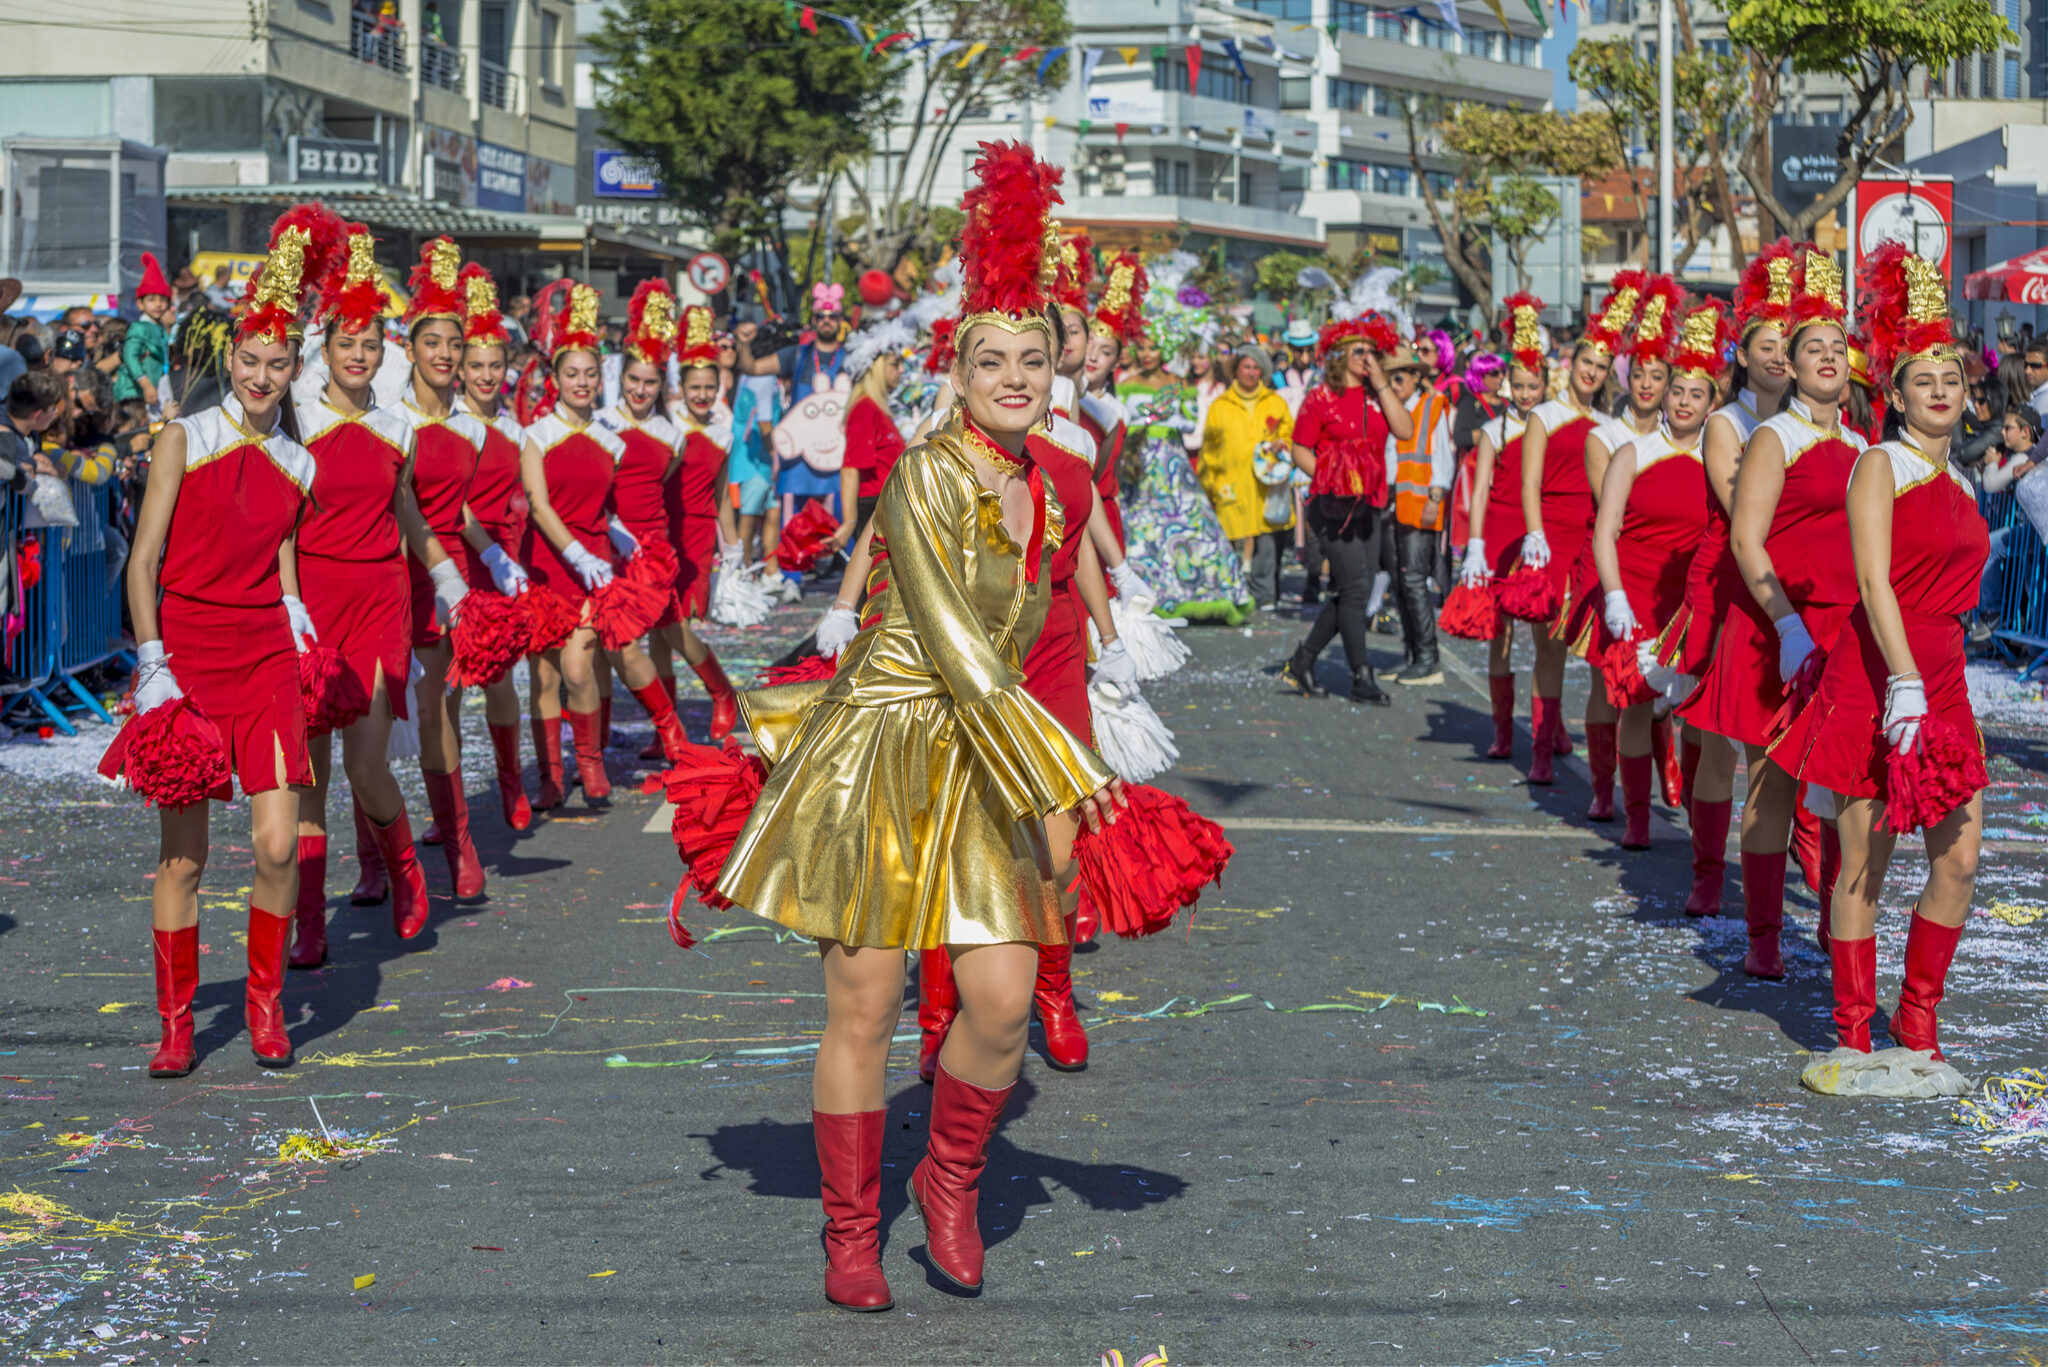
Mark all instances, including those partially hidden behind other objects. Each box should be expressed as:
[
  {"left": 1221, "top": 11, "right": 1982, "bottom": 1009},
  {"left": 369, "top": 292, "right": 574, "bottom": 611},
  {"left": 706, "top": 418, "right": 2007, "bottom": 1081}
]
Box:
[{"left": 954, "top": 141, "right": 1063, "bottom": 338}]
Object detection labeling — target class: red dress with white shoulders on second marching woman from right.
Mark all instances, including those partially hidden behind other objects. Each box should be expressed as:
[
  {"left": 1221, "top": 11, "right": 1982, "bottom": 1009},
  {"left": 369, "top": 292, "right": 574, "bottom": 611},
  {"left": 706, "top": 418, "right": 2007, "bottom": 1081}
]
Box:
[{"left": 1677, "top": 400, "right": 1864, "bottom": 746}]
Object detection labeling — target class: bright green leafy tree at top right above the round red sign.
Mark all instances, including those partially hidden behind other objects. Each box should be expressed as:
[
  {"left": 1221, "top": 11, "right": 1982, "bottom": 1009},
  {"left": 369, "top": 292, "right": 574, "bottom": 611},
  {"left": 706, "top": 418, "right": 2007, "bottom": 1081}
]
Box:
[{"left": 1729, "top": 0, "right": 2019, "bottom": 238}]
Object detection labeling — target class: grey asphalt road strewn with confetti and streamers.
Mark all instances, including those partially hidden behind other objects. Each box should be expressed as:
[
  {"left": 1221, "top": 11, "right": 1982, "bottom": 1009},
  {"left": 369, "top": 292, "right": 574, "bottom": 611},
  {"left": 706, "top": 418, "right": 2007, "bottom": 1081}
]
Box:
[{"left": 0, "top": 600, "right": 2048, "bottom": 1365}]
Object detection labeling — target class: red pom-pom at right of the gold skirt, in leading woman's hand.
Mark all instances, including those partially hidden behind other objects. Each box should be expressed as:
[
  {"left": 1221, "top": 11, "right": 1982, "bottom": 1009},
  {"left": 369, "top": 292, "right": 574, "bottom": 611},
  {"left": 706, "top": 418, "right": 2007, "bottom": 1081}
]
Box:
[{"left": 1073, "top": 783, "right": 1235, "bottom": 939}]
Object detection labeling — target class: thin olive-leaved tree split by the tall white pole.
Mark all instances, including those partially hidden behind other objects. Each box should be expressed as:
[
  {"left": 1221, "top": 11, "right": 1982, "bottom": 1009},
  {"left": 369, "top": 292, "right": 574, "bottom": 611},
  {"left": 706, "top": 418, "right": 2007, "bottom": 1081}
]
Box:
[{"left": 1567, "top": 34, "right": 1749, "bottom": 271}]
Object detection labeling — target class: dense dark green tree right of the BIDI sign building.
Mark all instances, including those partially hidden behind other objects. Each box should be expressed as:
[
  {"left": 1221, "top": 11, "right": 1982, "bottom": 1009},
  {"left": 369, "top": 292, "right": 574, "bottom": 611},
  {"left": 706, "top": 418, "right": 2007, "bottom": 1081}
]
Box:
[{"left": 590, "top": 0, "right": 905, "bottom": 256}]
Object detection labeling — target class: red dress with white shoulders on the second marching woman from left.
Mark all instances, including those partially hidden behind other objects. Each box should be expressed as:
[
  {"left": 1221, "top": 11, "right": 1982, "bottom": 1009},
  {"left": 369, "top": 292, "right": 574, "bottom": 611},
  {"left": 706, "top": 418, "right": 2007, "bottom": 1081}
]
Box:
[{"left": 299, "top": 404, "right": 414, "bottom": 717}]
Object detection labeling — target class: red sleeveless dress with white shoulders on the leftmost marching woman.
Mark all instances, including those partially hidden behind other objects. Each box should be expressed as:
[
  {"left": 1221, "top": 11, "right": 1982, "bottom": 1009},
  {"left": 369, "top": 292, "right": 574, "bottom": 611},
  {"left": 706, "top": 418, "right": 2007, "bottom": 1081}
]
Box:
[{"left": 138, "top": 393, "right": 317, "bottom": 801}]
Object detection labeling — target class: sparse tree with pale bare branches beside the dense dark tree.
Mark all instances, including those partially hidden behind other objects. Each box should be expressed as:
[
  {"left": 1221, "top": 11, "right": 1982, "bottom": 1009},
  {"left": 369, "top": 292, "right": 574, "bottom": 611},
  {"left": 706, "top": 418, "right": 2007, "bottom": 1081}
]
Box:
[{"left": 846, "top": 0, "right": 1075, "bottom": 273}]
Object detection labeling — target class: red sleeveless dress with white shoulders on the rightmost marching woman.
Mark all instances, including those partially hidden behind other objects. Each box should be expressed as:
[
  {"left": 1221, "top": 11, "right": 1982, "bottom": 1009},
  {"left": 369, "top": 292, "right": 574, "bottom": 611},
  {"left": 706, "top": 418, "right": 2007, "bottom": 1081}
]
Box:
[{"left": 1772, "top": 441, "right": 1991, "bottom": 797}]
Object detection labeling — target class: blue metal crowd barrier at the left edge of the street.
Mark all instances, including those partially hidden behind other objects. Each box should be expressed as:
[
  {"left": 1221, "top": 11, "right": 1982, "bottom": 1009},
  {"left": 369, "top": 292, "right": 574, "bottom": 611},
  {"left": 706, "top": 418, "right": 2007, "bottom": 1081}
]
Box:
[{"left": 0, "top": 480, "right": 127, "bottom": 736}]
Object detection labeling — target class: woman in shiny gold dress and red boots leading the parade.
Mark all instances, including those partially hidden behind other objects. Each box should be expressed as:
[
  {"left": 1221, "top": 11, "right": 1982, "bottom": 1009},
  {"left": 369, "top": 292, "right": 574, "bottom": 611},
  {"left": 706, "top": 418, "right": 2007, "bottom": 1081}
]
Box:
[{"left": 719, "top": 143, "right": 1122, "bottom": 1310}]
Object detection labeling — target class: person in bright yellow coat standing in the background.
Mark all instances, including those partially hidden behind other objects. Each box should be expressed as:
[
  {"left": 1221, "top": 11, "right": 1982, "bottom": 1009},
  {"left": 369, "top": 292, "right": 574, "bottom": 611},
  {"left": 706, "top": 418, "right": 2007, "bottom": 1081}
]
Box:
[{"left": 1196, "top": 342, "right": 1294, "bottom": 611}]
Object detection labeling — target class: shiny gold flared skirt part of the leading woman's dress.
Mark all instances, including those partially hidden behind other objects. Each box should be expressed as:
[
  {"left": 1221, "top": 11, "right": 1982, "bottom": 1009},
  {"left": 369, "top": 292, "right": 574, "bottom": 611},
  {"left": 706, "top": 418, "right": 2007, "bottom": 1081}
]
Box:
[{"left": 719, "top": 689, "right": 1067, "bottom": 949}]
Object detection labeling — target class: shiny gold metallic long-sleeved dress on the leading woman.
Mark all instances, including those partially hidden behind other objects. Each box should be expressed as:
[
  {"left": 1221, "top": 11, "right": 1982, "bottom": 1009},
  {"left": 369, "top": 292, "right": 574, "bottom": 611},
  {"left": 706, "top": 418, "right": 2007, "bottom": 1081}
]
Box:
[{"left": 719, "top": 418, "right": 1110, "bottom": 949}]
